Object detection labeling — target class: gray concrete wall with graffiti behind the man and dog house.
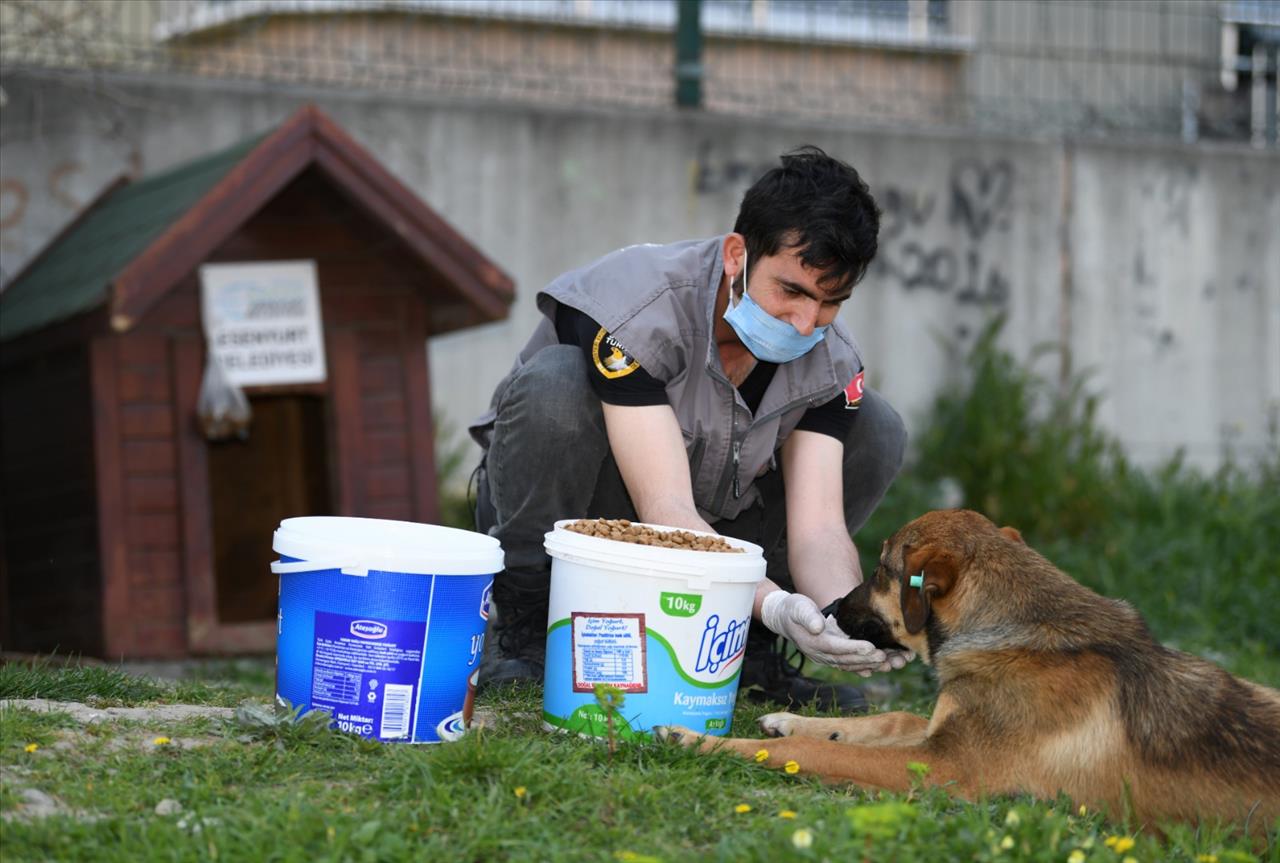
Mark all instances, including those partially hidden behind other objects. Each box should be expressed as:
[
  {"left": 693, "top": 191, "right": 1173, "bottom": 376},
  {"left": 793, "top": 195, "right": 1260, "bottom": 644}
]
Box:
[{"left": 0, "top": 76, "right": 1280, "bottom": 466}]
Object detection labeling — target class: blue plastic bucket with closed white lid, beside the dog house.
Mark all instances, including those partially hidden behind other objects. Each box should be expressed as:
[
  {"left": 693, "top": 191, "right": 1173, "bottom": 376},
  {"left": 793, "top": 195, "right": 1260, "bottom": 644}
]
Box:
[{"left": 271, "top": 516, "right": 503, "bottom": 743}]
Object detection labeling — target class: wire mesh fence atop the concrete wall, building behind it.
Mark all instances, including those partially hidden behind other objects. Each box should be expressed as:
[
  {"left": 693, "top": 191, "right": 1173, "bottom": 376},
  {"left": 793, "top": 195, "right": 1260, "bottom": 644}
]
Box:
[{"left": 0, "top": 0, "right": 1280, "bottom": 146}]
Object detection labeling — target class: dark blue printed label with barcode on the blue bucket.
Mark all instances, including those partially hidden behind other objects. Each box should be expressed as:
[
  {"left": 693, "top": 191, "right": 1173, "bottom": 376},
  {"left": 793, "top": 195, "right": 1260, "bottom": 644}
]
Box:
[{"left": 311, "top": 611, "right": 426, "bottom": 740}]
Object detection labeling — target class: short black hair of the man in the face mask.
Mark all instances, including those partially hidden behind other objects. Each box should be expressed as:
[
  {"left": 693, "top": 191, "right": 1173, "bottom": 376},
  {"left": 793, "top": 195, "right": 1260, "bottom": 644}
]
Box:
[{"left": 733, "top": 146, "right": 881, "bottom": 287}]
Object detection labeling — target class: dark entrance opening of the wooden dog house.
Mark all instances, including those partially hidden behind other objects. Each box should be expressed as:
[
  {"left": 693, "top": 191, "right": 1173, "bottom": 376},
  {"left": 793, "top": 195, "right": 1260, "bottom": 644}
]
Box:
[{"left": 209, "top": 396, "right": 333, "bottom": 624}]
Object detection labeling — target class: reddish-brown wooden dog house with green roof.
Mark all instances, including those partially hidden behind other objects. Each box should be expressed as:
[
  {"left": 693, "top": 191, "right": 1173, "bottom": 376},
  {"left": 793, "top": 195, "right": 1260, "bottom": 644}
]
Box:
[{"left": 0, "top": 108, "right": 513, "bottom": 658}]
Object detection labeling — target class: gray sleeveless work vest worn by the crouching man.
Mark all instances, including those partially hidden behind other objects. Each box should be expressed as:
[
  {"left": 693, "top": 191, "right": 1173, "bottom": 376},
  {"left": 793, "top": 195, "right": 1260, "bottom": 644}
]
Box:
[{"left": 471, "top": 237, "right": 863, "bottom": 521}]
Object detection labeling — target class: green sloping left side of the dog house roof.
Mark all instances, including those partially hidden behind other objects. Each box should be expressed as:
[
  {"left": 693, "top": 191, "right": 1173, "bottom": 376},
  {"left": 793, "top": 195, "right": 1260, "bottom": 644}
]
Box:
[{"left": 0, "top": 129, "right": 274, "bottom": 341}]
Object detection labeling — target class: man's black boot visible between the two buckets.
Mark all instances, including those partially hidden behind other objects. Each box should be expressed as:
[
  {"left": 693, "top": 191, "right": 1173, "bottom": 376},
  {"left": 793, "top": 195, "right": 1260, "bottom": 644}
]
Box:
[{"left": 479, "top": 569, "right": 550, "bottom": 688}]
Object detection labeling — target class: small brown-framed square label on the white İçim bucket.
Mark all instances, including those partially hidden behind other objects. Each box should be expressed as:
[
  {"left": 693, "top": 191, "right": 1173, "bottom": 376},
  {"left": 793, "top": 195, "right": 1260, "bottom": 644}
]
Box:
[{"left": 572, "top": 612, "right": 649, "bottom": 693}]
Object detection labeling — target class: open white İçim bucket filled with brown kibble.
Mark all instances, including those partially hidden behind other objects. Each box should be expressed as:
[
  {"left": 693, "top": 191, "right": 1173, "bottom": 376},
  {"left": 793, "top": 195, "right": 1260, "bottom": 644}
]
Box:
[{"left": 543, "top": 520, "right": 765, "bottom": 738}]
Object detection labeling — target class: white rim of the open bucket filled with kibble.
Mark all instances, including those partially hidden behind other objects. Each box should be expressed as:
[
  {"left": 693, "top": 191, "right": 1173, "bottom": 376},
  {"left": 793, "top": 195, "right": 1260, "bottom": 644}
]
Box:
[{"left": 544, "top": 519, "right": 765, "bottom": 584}]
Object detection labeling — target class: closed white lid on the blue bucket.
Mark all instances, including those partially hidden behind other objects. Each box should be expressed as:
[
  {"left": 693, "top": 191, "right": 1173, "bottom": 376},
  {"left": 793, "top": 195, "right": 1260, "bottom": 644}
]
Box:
[{"left": 271, "top": 516, "right": 503, "bottom": 575}]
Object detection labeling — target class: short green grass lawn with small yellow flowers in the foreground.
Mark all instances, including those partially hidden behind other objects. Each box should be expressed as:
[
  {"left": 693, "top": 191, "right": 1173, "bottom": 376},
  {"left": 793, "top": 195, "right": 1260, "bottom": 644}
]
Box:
[{"left": 0, "top": 635, "right": 1280, "bottom": 863}]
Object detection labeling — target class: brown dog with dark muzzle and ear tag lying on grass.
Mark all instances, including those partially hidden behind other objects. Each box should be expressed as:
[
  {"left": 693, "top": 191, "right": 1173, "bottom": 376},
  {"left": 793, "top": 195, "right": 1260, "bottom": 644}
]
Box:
[{"left": 659, "top": 510, "right": 1280, "bottom": 835}]
